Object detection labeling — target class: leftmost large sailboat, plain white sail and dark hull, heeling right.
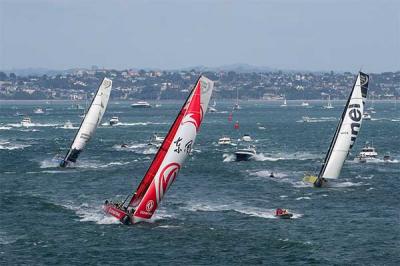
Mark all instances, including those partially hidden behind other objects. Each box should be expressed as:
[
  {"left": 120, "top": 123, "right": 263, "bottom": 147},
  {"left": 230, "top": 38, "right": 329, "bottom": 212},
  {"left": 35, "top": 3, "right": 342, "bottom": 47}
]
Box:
[{"left": 60, "top": 78, "right": 112, "bottom": 167}]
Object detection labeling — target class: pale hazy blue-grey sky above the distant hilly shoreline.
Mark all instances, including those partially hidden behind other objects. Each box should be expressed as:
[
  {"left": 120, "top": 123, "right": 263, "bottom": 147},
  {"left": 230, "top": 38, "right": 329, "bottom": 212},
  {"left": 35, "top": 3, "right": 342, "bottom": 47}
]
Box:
[{"left": 0, "top": 0, "right": 400, "bottom": 72}]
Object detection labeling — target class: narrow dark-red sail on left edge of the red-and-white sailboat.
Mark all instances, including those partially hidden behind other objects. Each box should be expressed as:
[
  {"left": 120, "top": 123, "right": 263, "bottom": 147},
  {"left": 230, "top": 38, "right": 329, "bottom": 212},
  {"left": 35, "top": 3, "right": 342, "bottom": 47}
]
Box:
[{"left": 129, "top": 79, "right": 200, "bottom": 207}]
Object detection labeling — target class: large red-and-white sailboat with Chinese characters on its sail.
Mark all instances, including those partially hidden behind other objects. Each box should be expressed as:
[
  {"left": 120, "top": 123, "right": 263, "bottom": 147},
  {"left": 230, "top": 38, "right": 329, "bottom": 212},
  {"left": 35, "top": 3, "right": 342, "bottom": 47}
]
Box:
[{"left": 103, "top": 76, "right": 214, "bottom": 224}]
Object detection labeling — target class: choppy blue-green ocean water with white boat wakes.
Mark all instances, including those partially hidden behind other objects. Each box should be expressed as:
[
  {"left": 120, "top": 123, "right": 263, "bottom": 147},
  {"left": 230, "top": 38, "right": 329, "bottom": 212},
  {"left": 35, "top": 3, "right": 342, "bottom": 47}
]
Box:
[{"left": 0, "top": 102, "right": 400, "bottom": 265}]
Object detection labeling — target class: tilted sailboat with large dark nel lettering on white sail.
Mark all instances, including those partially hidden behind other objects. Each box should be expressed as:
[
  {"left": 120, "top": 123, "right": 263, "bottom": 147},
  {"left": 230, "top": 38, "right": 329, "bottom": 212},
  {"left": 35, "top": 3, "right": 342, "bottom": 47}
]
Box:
[{"left": 304, "top": 72, "right": 369, "bottom": 187}]
